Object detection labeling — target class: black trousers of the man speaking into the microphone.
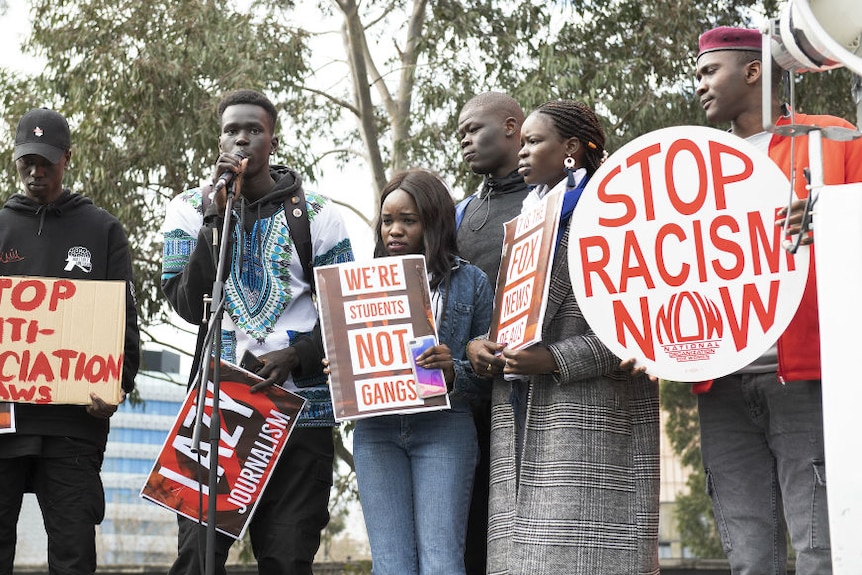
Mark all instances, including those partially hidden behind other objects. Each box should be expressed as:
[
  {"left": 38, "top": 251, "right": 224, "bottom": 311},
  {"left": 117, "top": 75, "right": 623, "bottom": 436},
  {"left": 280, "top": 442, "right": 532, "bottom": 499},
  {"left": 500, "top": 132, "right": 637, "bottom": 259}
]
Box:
[{"left": 168, "top": 427, "right": 335, "bottom": 575}]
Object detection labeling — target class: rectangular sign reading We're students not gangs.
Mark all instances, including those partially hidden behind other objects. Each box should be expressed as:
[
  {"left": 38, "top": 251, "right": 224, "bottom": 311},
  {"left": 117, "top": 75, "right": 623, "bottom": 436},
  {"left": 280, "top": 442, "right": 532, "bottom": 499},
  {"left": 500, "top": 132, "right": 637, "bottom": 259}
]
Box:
[{"left": 314, "top": 255, "right": 449, "bottom": 421}]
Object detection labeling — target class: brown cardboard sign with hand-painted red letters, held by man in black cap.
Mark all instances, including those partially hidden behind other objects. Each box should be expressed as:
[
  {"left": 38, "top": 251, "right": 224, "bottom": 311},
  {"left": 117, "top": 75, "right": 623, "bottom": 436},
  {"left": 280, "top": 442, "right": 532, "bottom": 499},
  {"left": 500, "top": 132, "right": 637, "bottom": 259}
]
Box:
[{"left": 0, "top": 276, "right": 127, "bottom": 405}]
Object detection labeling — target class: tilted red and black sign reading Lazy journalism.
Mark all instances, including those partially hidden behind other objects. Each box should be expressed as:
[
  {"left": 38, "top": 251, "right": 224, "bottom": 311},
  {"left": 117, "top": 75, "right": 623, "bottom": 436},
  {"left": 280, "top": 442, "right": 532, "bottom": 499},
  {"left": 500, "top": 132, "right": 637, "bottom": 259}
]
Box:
[{"left": 141, "top": 362, "right": 305, "bottom": 539}]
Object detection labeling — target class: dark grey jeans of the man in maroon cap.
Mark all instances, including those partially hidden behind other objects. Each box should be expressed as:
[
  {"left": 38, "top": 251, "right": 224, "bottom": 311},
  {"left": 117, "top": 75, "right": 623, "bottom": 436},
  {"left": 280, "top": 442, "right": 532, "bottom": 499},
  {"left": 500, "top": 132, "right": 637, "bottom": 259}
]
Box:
[{"left": 698, "top": 373, "right": 832, "bottom": 575}]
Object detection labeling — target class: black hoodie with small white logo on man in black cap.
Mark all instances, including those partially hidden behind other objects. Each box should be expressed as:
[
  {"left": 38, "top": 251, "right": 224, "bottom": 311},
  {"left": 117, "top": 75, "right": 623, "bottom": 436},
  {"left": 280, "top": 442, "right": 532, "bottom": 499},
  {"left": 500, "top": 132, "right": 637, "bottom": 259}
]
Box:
[{"left": 0, "top": 190, "right": 140, "bottom": 457}]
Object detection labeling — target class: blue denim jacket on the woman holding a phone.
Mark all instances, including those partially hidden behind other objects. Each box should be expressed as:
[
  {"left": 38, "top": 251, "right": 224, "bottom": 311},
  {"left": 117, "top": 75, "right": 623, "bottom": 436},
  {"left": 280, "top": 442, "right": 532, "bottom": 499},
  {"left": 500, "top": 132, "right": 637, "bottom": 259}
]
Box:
[{"left": 437, "top": 258, "right": 494, "bottom": 400}]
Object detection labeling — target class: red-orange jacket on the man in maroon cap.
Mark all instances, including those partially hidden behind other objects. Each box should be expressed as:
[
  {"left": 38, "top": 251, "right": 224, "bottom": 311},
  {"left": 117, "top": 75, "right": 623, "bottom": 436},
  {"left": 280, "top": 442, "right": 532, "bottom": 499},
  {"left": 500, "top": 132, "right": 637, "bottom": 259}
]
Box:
[{"left": 692, "top": 113, "right": 862, "bottom": 393}]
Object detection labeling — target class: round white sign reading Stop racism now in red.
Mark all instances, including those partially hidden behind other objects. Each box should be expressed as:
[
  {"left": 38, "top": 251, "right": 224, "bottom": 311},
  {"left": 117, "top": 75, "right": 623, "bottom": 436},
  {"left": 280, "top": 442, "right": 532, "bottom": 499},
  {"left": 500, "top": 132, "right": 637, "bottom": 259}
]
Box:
[{"left": 569, "top": 126, "right": 809, "bottom": 381}]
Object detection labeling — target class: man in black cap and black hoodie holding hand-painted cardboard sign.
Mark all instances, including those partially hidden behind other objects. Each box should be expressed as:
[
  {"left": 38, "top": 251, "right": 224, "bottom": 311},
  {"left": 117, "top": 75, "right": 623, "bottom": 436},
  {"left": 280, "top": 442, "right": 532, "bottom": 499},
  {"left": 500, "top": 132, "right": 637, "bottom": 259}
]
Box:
[{"left": 0, "top": 108, "right": 140, "bottom": 574}]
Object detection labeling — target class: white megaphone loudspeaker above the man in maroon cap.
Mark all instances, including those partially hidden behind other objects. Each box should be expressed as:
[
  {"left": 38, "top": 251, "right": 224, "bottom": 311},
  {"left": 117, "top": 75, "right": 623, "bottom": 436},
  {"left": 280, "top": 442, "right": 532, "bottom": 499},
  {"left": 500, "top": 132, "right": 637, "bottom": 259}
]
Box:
[{"left": 772, "top": 0, "right": 862, "bottom": 76}]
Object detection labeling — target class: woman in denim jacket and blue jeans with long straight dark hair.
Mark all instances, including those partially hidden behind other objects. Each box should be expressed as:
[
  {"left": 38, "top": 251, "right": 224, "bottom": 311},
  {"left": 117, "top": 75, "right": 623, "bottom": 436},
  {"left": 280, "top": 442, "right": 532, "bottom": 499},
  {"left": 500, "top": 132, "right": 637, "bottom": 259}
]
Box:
[{"left": 353, "top": 169, "right": 493, "bottom": 575}]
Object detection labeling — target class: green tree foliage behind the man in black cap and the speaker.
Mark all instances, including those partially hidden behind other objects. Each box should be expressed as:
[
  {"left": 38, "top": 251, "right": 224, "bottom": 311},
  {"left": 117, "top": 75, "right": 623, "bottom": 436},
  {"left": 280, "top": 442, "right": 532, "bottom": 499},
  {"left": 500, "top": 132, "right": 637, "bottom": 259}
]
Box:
[{"left": 0, "top": 0, "right": 316, "bottom": 325}]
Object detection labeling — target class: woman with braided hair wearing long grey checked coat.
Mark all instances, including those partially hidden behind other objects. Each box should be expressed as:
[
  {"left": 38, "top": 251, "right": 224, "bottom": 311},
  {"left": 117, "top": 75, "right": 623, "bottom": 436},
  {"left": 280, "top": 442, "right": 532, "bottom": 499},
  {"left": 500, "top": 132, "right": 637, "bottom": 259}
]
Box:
[{"left": 467, "top": 100, "right": 659, "bottom": 575}]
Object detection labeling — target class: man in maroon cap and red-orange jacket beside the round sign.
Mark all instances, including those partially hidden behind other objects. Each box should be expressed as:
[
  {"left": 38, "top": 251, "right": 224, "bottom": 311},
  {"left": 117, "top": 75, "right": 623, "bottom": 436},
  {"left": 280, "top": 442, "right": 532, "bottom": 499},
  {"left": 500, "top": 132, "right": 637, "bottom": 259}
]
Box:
[{"left": 695, "top": 27, "right": 862, "bottom": 575}]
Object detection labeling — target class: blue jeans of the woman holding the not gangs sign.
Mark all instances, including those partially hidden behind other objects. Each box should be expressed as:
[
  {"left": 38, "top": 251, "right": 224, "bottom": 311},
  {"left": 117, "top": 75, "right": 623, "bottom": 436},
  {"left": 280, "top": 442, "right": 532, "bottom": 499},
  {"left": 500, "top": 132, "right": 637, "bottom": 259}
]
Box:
[{"left": 353, "top": 400, "right": 479, "bottom": 575}]
